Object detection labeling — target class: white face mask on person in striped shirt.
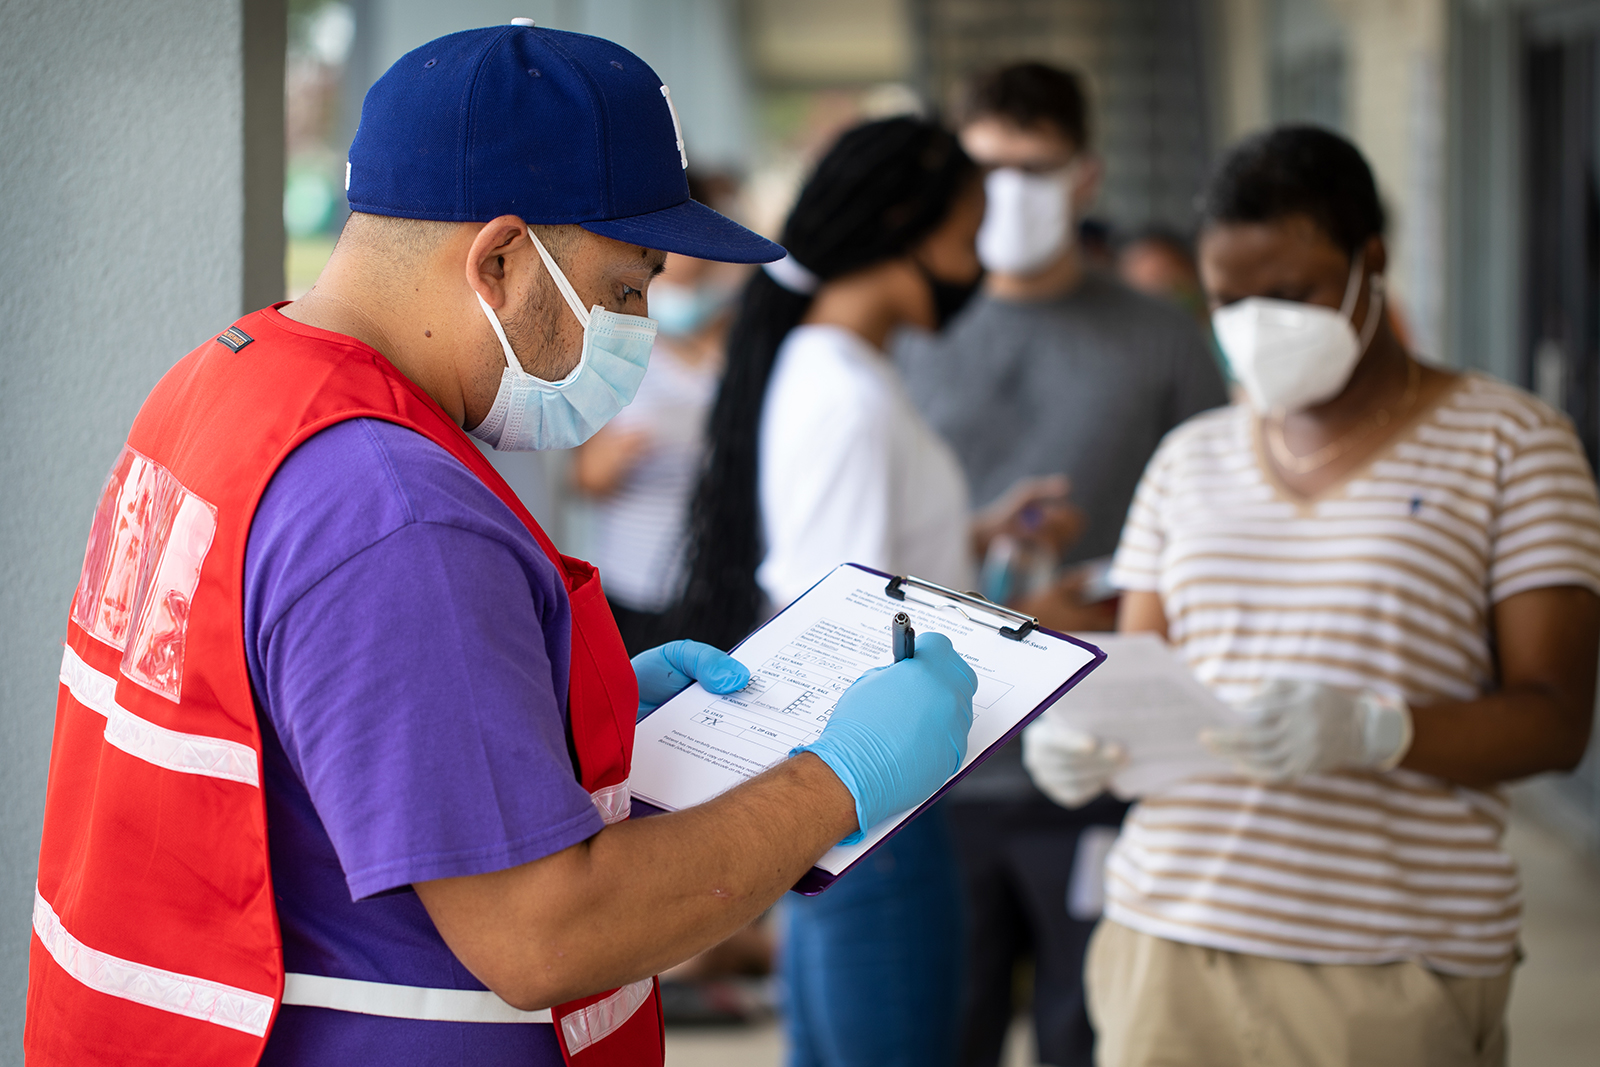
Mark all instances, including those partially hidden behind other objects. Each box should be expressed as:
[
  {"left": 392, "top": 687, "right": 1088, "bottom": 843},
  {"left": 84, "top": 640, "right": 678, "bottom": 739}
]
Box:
[{"left": 1211, "top": 258, "right": 1384, "bottom": 413}]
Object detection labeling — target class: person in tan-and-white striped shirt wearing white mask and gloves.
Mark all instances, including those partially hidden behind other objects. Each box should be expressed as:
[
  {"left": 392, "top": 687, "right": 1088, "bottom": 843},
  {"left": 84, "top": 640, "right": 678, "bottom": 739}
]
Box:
[{"left": 1027, "top": 128, "right": 1600, "bottom": 1067}]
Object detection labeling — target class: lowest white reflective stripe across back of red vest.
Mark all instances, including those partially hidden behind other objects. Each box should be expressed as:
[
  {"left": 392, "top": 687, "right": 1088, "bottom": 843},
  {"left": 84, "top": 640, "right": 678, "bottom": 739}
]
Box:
[{"left": 34, "top": 886, "right": 272, "bottom": 1037}]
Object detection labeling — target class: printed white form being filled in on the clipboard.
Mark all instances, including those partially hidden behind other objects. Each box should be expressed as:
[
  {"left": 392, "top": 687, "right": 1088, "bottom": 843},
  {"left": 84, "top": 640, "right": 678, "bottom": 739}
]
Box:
[{"left": 630, "top": 565, "right": 1094, "bottom": 873}]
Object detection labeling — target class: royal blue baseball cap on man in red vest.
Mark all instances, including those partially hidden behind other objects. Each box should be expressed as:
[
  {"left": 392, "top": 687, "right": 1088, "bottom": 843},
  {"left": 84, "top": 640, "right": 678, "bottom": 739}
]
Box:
[{"left": 344, "top": 19, "right": 784, "bottom": 262}]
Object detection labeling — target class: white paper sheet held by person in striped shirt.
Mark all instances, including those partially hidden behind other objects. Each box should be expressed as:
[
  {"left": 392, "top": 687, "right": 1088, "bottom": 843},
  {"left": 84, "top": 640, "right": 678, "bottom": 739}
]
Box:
[{"left": 1045, "top": 633, "right": 1237, "bottom": 800}]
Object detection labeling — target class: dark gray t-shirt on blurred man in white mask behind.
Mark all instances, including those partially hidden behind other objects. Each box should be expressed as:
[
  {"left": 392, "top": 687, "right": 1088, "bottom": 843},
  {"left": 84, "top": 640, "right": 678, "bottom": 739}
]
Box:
[{"left": 894, "top": 274, "right": 1227, "bottom": 800}]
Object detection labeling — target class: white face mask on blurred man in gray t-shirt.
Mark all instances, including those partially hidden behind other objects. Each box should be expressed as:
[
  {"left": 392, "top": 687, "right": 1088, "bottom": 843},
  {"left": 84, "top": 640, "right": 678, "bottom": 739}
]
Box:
[{"left": 978, "top": 163, "right": 1075, "bottom": 275}]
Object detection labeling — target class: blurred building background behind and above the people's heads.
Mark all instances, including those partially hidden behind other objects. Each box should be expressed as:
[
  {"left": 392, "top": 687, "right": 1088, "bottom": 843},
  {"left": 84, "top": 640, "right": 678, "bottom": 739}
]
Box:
[{"left": 283, "top": 0, "right": 1600, "bottom": 870}]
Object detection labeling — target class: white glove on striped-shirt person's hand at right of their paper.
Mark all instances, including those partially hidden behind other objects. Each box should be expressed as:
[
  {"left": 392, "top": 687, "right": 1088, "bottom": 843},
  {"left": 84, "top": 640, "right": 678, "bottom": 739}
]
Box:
[{"left": 1200, "top": 678, "right": 1411, "bottom": 781}]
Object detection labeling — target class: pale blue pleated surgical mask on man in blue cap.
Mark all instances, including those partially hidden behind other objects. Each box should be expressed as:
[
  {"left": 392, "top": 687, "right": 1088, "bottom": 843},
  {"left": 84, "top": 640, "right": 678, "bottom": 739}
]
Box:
[{"left": 467, "top": 229, "right": 656, "bottom": 453}]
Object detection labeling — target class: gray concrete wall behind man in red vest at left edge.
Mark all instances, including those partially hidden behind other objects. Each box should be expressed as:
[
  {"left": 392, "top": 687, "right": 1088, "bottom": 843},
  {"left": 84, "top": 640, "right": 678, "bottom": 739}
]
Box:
[{"left": 0, "top": 0, "right": 285, "bottom": 1064}]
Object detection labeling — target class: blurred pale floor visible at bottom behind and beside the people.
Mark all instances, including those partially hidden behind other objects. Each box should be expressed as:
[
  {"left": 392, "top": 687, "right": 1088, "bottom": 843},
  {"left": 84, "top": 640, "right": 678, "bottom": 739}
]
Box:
[{"left": 667, "top": 821, "right": 1600, "bottom": 1067}]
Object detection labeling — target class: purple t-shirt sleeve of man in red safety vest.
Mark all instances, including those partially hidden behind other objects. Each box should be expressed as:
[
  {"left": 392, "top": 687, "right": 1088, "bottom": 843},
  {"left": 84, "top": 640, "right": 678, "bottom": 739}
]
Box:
[{"left": 258, "top": 522, "right": 603, "bottom": 899}]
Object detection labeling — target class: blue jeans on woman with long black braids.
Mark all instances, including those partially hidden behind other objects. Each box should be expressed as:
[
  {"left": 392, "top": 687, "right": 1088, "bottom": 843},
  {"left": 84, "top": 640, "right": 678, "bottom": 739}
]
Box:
[{"left": 781, "top": 806, "right": 963, "bottom": 1067}]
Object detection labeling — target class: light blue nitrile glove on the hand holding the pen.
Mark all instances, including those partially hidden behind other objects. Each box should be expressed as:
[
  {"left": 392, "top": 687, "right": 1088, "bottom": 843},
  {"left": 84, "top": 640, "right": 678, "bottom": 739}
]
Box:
[{"left": 789, "top": 633, "right": 978, "bottom": 845}]
